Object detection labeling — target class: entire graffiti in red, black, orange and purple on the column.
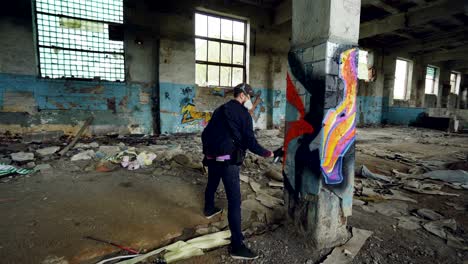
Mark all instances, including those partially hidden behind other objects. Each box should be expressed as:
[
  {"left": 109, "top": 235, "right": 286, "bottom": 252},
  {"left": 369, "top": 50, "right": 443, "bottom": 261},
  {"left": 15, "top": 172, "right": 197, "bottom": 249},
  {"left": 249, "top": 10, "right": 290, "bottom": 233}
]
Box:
[{"left": 283, "top": 47, "right": 358, "bottom": 193}]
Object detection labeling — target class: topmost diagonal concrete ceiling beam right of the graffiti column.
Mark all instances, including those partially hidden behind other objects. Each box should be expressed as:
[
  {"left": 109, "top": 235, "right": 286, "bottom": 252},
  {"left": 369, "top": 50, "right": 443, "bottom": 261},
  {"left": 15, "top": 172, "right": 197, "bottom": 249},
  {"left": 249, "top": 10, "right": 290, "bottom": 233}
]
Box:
[{"left": 359, "top": 1, "right": 464, "bottom": 39}]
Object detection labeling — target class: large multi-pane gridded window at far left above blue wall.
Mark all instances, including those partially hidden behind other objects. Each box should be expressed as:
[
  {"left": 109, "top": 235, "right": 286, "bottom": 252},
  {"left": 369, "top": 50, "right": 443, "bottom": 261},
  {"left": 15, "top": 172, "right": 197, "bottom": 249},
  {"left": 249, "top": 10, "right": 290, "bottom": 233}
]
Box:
[{"left": 33, "top": 0, "right": 125, "bottom": 81}]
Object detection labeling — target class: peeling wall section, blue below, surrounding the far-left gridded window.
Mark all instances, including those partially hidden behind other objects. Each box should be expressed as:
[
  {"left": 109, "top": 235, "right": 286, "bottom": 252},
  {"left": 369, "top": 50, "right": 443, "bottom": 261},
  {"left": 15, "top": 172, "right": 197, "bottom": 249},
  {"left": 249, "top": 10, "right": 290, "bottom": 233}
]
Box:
[{"left": 0, "top": 0, "right": 157, "bottom": 134}]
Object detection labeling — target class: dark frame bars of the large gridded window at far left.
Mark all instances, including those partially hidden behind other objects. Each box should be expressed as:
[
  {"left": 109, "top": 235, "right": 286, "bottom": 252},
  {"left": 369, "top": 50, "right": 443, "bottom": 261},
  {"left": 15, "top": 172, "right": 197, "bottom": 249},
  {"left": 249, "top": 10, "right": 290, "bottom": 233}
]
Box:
[{"left": 31, "top": 0, "right": 127, "bottom": 83}]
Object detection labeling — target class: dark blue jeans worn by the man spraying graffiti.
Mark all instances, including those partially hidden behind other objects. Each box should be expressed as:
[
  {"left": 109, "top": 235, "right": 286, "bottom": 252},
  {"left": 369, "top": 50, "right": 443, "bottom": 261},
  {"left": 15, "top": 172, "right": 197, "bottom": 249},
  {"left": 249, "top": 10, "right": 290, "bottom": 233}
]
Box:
[{"left": 205, "top": 161, "right": 244, "bottom": 248}]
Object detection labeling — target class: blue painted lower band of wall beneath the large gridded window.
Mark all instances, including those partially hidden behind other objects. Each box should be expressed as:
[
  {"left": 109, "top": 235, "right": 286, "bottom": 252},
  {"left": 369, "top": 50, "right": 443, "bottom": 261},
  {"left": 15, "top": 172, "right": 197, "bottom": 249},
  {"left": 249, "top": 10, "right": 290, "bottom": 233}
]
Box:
[{"left": 0, "top": 73, "right": 154, "bottom": 134}]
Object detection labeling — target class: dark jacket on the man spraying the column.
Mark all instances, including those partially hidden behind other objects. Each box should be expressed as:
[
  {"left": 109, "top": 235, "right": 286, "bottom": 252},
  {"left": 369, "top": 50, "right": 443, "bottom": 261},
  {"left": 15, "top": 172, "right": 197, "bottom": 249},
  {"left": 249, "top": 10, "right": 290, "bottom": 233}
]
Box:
[{"left": 202, "top": 100, "right": 270, "bottom": 157}]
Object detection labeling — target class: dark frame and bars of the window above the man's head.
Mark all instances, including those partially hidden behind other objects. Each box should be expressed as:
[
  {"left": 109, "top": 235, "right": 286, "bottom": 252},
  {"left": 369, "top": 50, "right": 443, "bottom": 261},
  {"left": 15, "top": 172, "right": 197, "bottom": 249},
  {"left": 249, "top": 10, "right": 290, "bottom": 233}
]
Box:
[{"left": 193, "top": 10, "right": 249, "bottom": 88}]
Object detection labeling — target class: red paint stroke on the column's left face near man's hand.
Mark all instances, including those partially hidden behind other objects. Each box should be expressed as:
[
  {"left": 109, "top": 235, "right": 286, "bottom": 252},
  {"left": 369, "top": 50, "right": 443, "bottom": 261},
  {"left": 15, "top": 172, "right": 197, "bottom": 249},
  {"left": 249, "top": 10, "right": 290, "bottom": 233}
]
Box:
[{"left": 283, "top": 72, "right": 314, "bottom": 167}]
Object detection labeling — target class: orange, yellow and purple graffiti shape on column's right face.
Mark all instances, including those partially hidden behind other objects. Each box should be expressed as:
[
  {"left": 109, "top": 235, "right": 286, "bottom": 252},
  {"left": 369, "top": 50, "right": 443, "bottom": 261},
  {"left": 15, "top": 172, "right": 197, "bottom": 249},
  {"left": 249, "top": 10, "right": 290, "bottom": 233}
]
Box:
[{"left": 320, "top": 49, "right": 358, "bottom": 184}]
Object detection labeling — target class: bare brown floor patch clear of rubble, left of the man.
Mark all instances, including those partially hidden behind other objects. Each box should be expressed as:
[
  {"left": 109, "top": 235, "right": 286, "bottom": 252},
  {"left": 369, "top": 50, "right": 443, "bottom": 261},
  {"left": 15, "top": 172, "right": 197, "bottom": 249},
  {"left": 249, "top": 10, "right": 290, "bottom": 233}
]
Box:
[{"left": 0, "top": 165, "right": 210, "bottom": 263}]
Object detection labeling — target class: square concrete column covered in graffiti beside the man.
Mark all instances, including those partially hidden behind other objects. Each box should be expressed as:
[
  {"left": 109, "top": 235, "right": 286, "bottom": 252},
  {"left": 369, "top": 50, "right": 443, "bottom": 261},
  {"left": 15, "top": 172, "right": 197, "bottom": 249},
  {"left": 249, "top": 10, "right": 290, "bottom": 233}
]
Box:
[{"left": 284, "top": 0, "right": 361, "bottom": 249}]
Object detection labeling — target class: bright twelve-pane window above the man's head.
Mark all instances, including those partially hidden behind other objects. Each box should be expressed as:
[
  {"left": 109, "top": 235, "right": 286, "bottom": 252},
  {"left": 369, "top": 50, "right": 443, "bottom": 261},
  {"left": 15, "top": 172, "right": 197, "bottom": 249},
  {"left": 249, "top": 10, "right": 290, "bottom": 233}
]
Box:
[{"left": 195, "top": 13, "right": 247, "bottom": 87}]
